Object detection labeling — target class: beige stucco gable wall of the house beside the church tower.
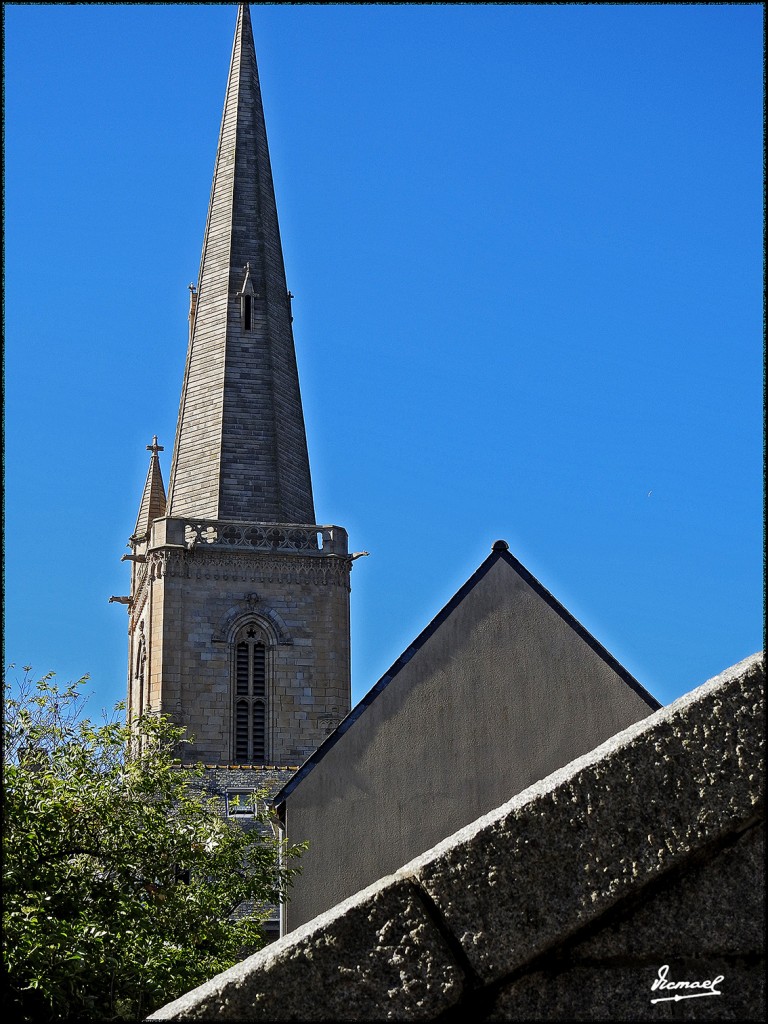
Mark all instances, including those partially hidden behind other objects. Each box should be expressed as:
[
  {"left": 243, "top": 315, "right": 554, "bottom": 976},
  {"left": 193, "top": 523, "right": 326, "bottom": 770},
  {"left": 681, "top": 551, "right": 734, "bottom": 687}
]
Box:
[{"left": 285, "top": 555, "right": 658, "bottom": 930}]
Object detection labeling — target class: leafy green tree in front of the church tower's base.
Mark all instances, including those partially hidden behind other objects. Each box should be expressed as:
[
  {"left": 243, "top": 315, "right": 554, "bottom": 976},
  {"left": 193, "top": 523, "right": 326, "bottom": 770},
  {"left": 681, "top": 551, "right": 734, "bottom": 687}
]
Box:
[{"left": 3, "top": 673, "right": 299, "bottom": 1022}]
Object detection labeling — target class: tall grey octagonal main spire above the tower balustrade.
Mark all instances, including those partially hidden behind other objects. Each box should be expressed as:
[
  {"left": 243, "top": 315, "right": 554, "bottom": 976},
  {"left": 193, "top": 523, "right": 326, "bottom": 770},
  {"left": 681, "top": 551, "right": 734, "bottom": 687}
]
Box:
[{"left": 168, "top": 4, "right": 314, "bottom": 523}]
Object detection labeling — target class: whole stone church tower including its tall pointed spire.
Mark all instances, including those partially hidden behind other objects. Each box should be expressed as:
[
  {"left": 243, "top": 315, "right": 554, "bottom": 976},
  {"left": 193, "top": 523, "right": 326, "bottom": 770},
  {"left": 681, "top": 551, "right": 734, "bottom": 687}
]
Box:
[{"left": 117, "top": 4, "right": 351, "bottom": 765}]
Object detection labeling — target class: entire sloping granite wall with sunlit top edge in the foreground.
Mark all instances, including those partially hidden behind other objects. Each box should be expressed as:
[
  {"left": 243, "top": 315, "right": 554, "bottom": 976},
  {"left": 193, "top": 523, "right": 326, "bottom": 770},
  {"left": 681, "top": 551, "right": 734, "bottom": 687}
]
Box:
[{"left": 148, "top": 654, "right": 765, "bottom": 1024}]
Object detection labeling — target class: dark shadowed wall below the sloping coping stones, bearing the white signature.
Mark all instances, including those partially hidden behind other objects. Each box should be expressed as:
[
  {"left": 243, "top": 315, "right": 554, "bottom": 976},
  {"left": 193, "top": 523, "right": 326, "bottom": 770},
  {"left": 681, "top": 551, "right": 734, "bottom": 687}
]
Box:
[{"left": 481, "top": 822, "right": 765, "bottom": 1021}]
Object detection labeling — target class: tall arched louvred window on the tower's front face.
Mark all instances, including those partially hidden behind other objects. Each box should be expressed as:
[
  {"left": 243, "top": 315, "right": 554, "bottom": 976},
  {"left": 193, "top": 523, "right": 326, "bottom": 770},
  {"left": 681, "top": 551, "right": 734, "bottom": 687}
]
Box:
[{"left": 233, "top": 624, "right": 269, "bottom": 764}]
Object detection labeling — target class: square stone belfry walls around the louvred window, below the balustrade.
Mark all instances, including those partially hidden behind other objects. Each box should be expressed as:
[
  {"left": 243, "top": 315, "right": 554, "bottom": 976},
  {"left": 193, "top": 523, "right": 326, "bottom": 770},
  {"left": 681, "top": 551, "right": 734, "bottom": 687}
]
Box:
[{"left": 136, "top": 546, "right": 351, "bottom": 764}]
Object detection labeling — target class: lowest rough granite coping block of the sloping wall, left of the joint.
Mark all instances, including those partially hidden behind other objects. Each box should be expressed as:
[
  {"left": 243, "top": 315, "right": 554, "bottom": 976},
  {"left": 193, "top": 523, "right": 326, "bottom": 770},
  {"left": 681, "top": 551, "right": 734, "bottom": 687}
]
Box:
[{"left": 148, "top": 879, "right": 463, "bottom": 1021}]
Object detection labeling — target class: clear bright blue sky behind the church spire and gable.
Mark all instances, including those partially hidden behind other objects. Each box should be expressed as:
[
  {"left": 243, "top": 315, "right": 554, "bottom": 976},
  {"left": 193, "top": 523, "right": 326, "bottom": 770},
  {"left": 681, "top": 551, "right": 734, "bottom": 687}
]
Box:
[{"left": 4, "top": 4, "right": 763, "bottom": 720}]
